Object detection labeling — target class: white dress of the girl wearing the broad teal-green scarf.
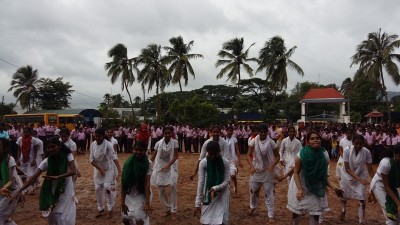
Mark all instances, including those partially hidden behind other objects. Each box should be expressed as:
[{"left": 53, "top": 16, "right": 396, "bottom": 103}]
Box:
[{"left": 287, "top": 151, "right": 329, "bottom": 216}]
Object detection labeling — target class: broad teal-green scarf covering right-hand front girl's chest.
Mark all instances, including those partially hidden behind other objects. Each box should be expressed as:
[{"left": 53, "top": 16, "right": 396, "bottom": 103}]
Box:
[{"left": 300, "top": 146, "right": 328, "bottom": 197}]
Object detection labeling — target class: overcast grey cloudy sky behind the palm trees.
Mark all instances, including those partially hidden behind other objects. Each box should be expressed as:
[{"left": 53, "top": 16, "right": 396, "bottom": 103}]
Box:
[{"left": 0, "top": 0, "right": 400, "bottom": 111}]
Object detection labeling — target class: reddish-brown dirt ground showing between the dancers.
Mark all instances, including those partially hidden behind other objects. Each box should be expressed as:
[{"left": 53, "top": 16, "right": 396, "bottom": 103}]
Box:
[{"left": 12, "top": 153, "right": 384, "bottom": 225}]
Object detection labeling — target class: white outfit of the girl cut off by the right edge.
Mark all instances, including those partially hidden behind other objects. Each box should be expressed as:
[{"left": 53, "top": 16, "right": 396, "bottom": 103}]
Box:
[{"left": 370, "top": 158, "right": 400, "bottom": 225}]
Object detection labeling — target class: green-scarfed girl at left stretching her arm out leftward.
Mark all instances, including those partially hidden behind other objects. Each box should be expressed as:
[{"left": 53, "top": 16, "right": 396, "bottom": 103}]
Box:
[{"left": 12, "top": 137, "right": 76, "bottom": 225}]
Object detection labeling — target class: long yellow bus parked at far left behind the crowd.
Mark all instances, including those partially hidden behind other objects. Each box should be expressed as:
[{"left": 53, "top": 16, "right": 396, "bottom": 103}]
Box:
[{"left": 3, "top": 113, "right": 59, "bottom": 128}]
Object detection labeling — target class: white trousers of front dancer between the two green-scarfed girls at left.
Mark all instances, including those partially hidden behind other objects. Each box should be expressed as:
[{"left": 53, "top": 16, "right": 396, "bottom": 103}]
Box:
[{"left": 94, "top": 183, "right": 117, "bottom": 211}]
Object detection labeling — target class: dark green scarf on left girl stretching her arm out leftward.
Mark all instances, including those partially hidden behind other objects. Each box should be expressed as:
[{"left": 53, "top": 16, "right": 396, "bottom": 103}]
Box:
[{"left": 39, "top": 151, "right": 68, "bottom": 211}]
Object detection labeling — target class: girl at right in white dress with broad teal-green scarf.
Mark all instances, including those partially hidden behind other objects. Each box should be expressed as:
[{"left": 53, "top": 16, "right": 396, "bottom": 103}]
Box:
[{"left": 287, "top": 132, "right": 341, "bottom": 225}]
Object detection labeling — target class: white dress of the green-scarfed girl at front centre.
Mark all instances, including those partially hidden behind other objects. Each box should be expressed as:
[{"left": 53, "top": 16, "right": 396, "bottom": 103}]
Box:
[{"left": 195, "top": 158, "right": 230, "bottom": 225}]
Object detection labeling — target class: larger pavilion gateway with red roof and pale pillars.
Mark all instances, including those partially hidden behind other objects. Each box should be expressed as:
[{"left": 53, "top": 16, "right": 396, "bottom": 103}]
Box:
[{"left": 300, "top": 88, "right": 350, "bottom": 123}]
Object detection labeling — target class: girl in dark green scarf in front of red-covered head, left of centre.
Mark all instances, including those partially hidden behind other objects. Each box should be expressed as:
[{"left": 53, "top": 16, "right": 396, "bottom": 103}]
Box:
[{"left": 121, "top": 141, "right": 151, "bottom": 225}]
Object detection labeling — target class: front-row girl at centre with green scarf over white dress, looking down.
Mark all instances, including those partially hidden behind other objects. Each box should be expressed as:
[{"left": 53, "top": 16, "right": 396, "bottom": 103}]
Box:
[{"left": 194, "top": 141, "right": 230, "bottom": 225}]
